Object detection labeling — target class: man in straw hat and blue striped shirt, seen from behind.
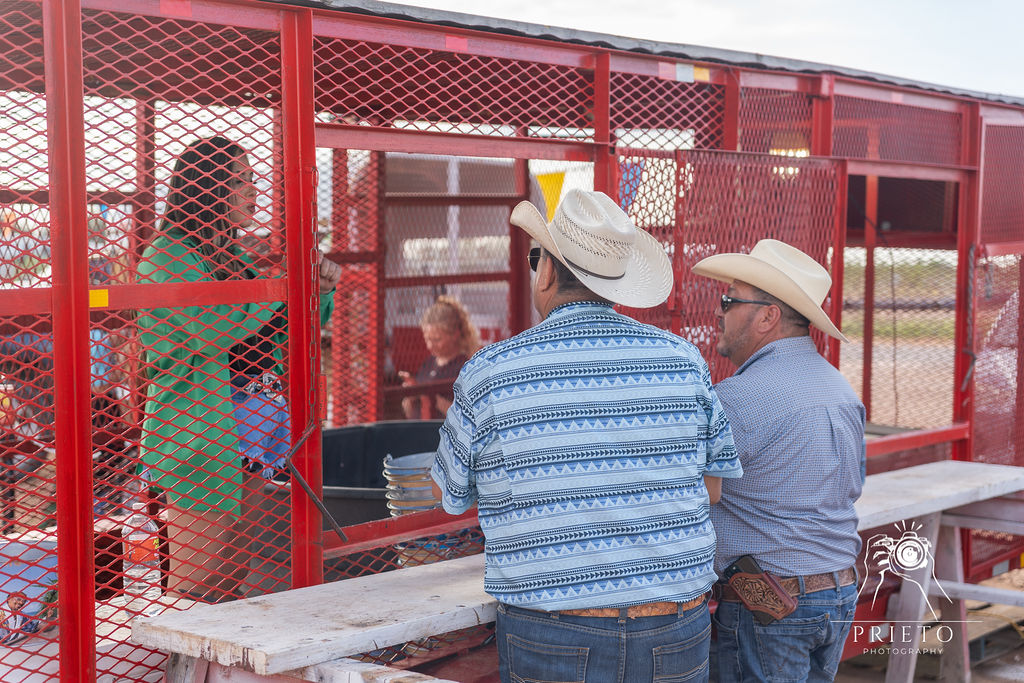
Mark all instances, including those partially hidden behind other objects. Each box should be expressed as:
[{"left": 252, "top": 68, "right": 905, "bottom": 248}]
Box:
[{"left": 431, "top": 190, "right": 742, "bottom": 683}]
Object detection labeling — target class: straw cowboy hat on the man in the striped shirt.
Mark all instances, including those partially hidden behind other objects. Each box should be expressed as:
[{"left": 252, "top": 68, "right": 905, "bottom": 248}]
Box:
[{"left": 510, "top": 189, "right": 672, "bottom": 308}]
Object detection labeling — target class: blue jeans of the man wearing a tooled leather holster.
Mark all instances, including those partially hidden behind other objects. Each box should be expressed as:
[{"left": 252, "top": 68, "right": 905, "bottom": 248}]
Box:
[{"left": 713, "top": 584, "right": 857, "bottom": 683}]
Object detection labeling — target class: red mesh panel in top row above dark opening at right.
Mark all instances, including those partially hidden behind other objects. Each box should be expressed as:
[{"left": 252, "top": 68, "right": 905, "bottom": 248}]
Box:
[{"left": 833, "top": 95, "right": 962, "bottom": 164}]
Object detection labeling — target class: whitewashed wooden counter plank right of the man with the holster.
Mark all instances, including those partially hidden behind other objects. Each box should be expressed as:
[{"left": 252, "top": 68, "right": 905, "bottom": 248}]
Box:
[{"left": 856, "top": 460, "right": 1024, "bottom": 529}]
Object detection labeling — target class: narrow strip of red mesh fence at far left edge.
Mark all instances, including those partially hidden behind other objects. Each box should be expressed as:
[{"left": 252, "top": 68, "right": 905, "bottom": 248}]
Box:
[{"left": 0, "top": 2, "right": 58, "bottom": 681}]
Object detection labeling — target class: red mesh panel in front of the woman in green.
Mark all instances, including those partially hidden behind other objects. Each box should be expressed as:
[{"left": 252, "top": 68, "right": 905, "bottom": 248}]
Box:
[{"left": 75, "top": 10, "right": 299, "bottom": 681}]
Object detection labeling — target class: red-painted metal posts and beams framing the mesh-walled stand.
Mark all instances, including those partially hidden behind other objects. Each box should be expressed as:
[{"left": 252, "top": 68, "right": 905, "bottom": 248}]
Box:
[{"left": 0, "top": 0, "right": 1024, "bottom": 681}]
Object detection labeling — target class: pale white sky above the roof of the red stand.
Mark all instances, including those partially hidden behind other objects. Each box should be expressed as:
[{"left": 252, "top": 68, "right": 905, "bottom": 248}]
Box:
[{"left": 398, "top": 0, "right": 1024, "bottom": 97}]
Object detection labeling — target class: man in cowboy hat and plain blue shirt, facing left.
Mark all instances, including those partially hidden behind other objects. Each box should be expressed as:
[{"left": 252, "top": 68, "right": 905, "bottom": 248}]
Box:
[{"left": 693, "top": 240, "right": 864, "bottom": 683}]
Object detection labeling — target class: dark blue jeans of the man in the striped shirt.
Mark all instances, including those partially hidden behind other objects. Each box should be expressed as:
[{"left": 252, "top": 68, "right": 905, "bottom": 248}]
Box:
[{"left": 496, "top": 601, "right": 711, "bottom": 683}]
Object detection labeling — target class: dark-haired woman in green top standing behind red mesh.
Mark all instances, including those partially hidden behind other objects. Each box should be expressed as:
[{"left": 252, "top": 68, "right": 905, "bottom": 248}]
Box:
[{"left": 138, "top": 136, "right": 341, "bottom": 601}]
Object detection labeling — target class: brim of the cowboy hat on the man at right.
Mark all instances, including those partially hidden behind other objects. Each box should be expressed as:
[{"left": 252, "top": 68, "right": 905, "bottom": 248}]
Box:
[{"left": 692, "top": 254, "right": 850, "bottom": 342}]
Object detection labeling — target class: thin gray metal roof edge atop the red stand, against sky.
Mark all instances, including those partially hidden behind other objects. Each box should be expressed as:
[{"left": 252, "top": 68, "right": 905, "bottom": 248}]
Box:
[{"left": 270, "top": 0, "right": 1024, "bottom": 106}]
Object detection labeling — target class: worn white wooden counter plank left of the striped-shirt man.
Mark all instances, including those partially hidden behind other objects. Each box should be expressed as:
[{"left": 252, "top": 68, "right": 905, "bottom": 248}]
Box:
[{"left": 132, "top": 555, "right": 497, "bottom": 675}]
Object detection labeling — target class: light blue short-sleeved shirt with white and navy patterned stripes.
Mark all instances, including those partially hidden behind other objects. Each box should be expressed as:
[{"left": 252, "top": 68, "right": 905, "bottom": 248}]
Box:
[{"left": 431, "top": 302, "right": 742, "bottom": 610}]
